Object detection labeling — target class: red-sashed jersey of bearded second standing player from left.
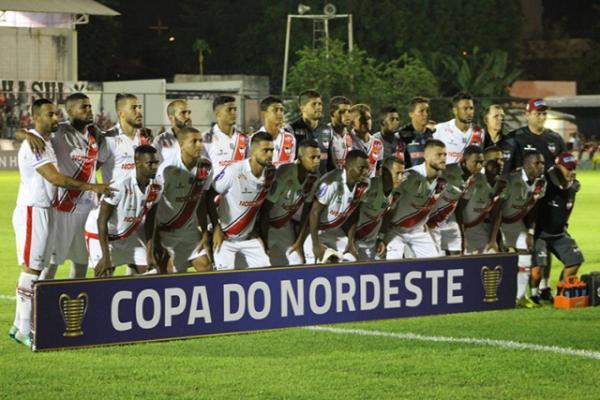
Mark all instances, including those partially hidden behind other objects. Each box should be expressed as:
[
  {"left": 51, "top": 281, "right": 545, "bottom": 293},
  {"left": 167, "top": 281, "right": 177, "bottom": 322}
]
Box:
[{"left": 51, "top": 122, "right": 102, "bottom": 214}]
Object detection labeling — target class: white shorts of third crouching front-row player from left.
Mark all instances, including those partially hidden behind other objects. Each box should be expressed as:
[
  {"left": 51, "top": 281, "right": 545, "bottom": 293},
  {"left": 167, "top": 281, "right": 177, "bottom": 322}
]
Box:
[{"left": 214, "top": 239, "right": 271, "bottom": 271}]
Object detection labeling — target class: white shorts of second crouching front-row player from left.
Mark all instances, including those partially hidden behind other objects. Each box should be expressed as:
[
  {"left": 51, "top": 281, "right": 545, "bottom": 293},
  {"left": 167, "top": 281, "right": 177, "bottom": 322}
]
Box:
[{"left": 160, "top": 224, "right": 206, "bottom": 272}]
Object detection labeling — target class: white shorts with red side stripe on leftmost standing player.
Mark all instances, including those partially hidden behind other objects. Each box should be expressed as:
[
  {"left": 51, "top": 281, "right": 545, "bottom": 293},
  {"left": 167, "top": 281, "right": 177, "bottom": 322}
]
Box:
[{"left": 12, "top": 206, "right": 54, "bottom": 271}]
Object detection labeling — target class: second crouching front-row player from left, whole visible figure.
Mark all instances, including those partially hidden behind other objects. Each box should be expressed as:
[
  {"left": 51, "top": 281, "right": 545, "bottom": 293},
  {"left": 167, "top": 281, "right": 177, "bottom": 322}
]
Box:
[{"left": 156, "top": 127, "right": 212, "bottom": 272}]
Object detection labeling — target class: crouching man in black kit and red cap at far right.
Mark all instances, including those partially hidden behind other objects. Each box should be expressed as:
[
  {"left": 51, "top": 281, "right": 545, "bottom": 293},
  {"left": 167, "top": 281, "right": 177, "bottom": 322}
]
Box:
[{"left": 531, "top": 152, "right": 583, "bottom": 303}]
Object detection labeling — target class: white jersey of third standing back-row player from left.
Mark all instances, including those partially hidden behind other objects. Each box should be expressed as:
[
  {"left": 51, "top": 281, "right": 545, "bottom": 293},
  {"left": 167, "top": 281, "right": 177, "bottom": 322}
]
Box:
[{"left": 98, "top": 124, "right": 148, "bottom": 183}]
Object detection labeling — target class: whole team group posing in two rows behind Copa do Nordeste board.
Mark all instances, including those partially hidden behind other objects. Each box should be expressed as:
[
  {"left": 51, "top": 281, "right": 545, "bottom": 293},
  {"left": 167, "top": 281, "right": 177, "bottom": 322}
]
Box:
[{"left": 9, "top": 90, "right": 584, "bottom": 346}]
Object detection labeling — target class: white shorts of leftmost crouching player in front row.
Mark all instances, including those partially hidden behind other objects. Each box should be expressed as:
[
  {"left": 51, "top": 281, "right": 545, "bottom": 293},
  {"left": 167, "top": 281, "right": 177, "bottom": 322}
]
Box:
[{"left": 86, "top": 232, "right": 148, "bottom": 268}]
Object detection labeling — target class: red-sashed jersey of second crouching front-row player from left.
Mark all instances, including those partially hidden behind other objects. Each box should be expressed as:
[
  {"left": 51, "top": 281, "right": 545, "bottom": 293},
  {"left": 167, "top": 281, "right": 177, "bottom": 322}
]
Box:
[{"left": 156, "top": 153, "right": 212, "bottom": 230}]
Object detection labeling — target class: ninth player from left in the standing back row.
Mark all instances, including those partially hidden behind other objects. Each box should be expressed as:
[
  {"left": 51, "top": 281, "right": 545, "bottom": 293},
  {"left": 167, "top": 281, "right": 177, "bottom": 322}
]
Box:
[{"left": 350, "top": 104, "right": 383, "bottom": 177}]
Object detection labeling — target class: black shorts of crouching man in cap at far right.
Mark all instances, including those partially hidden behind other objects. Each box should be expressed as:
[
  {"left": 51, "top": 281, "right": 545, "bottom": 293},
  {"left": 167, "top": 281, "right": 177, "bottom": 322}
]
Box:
[{"left": 533, "top": 232, "right": 583, "bottom": 267}]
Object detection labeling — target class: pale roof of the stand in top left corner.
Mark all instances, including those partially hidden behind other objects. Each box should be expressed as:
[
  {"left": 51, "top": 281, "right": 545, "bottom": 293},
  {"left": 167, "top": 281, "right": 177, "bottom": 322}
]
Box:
[{"left": 0, "top": 0, "right": 119, "bottom": 16}]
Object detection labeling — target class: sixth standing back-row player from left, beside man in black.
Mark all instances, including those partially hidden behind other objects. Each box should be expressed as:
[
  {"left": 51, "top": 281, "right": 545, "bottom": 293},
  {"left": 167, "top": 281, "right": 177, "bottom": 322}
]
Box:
[{"left": 258, "top": 96, "right": 296, "bottom": 168}]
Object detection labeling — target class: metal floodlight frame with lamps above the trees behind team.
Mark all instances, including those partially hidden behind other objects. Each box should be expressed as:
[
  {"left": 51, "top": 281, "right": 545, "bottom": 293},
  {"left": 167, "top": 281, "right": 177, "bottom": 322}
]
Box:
[{"left": 281, "top": 3, "right": 354, "bottom": 93}]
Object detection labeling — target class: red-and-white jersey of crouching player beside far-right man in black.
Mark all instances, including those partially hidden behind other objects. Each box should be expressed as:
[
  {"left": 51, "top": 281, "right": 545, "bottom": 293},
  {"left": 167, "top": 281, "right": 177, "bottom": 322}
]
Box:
[{"left": 502, "top": 169, "right": 546, "bottom": 224}]
